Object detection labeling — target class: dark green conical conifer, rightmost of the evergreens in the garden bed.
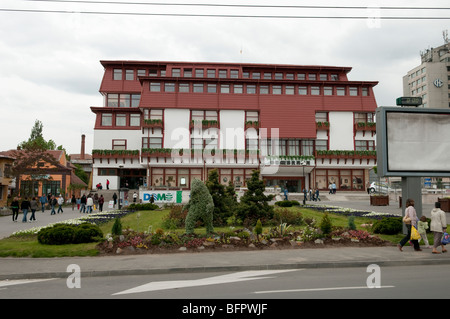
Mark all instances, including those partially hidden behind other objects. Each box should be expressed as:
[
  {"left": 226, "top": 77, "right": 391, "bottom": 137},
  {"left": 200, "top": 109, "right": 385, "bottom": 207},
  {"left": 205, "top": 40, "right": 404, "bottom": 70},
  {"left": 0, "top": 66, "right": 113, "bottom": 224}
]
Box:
[{"left": 236, "top": 170, "right": 274, "bottom": 226}]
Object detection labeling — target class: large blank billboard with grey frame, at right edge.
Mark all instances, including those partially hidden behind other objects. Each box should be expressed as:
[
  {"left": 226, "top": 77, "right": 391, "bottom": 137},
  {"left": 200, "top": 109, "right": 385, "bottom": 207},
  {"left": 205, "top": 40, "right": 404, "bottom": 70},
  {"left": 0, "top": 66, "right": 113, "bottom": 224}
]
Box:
[{"left": 376, "top": 107, "right": 450, "bottom": 177}]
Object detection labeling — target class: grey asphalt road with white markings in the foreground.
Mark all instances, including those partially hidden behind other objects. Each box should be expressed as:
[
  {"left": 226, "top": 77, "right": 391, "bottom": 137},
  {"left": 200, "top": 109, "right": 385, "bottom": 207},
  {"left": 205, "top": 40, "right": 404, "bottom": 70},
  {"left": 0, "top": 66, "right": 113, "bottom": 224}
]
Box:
[{"left": 0, "top": 265, "right": 450, "bottom": 302}]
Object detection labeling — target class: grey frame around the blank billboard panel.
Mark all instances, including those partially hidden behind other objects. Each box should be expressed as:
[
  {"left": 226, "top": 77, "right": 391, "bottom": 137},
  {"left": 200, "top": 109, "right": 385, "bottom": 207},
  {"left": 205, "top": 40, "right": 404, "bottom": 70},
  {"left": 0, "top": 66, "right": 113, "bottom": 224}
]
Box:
[{"left": 376, "top": 106, "right": 450, "bottom": 177}]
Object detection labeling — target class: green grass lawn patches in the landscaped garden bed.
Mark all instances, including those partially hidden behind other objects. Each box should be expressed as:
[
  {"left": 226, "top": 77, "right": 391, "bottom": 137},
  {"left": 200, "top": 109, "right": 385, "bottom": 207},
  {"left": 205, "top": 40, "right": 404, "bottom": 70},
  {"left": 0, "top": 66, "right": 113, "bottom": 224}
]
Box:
[{"left": 0, "top": 207, "right": 414, "bottom": 257}]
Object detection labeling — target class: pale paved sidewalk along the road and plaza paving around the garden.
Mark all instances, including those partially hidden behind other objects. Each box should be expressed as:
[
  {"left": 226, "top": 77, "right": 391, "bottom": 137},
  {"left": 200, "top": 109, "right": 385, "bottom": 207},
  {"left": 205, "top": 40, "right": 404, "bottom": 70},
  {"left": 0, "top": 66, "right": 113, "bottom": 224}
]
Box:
[{"left": 0, "top": 194, "right": 450, "bottom": 280}]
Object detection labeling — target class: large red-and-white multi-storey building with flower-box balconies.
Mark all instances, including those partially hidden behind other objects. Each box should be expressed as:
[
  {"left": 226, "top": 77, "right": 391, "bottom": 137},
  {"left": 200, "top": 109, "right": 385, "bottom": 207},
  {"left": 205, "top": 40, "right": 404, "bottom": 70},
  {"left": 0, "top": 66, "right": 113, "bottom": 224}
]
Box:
[{"left": 91, "top": 60, "right": 377, "bottom": 192}]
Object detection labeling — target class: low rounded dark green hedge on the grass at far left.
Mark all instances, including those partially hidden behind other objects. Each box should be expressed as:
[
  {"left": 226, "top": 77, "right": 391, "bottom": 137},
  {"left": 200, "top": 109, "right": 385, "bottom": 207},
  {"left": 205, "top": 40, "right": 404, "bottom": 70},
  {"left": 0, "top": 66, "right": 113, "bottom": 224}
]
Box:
[{"left": 37, "top": 223, "right": 103, "bottom": 245}]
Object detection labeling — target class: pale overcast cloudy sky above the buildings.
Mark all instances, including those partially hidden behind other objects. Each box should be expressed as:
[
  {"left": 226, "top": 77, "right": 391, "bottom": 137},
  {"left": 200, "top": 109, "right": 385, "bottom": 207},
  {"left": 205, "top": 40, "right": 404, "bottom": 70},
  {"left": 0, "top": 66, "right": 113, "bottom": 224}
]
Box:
[{"left": 0, "top": 0, "right": 450, "bottom": 154}]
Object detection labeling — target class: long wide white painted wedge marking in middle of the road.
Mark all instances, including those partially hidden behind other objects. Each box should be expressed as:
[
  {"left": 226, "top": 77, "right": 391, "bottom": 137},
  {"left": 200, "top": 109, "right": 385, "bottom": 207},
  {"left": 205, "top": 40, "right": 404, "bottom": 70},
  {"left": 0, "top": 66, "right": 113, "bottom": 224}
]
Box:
[{"left": 113, "top": 269, "right": 299, "bottom": 296}]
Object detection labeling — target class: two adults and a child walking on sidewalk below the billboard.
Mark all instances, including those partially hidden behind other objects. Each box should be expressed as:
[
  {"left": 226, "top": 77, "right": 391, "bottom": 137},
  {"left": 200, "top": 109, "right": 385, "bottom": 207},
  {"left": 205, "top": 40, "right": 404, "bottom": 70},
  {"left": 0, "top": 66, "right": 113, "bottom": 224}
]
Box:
[{"left": 397, "top": 199, "right": 447, "bottom": 254}]
